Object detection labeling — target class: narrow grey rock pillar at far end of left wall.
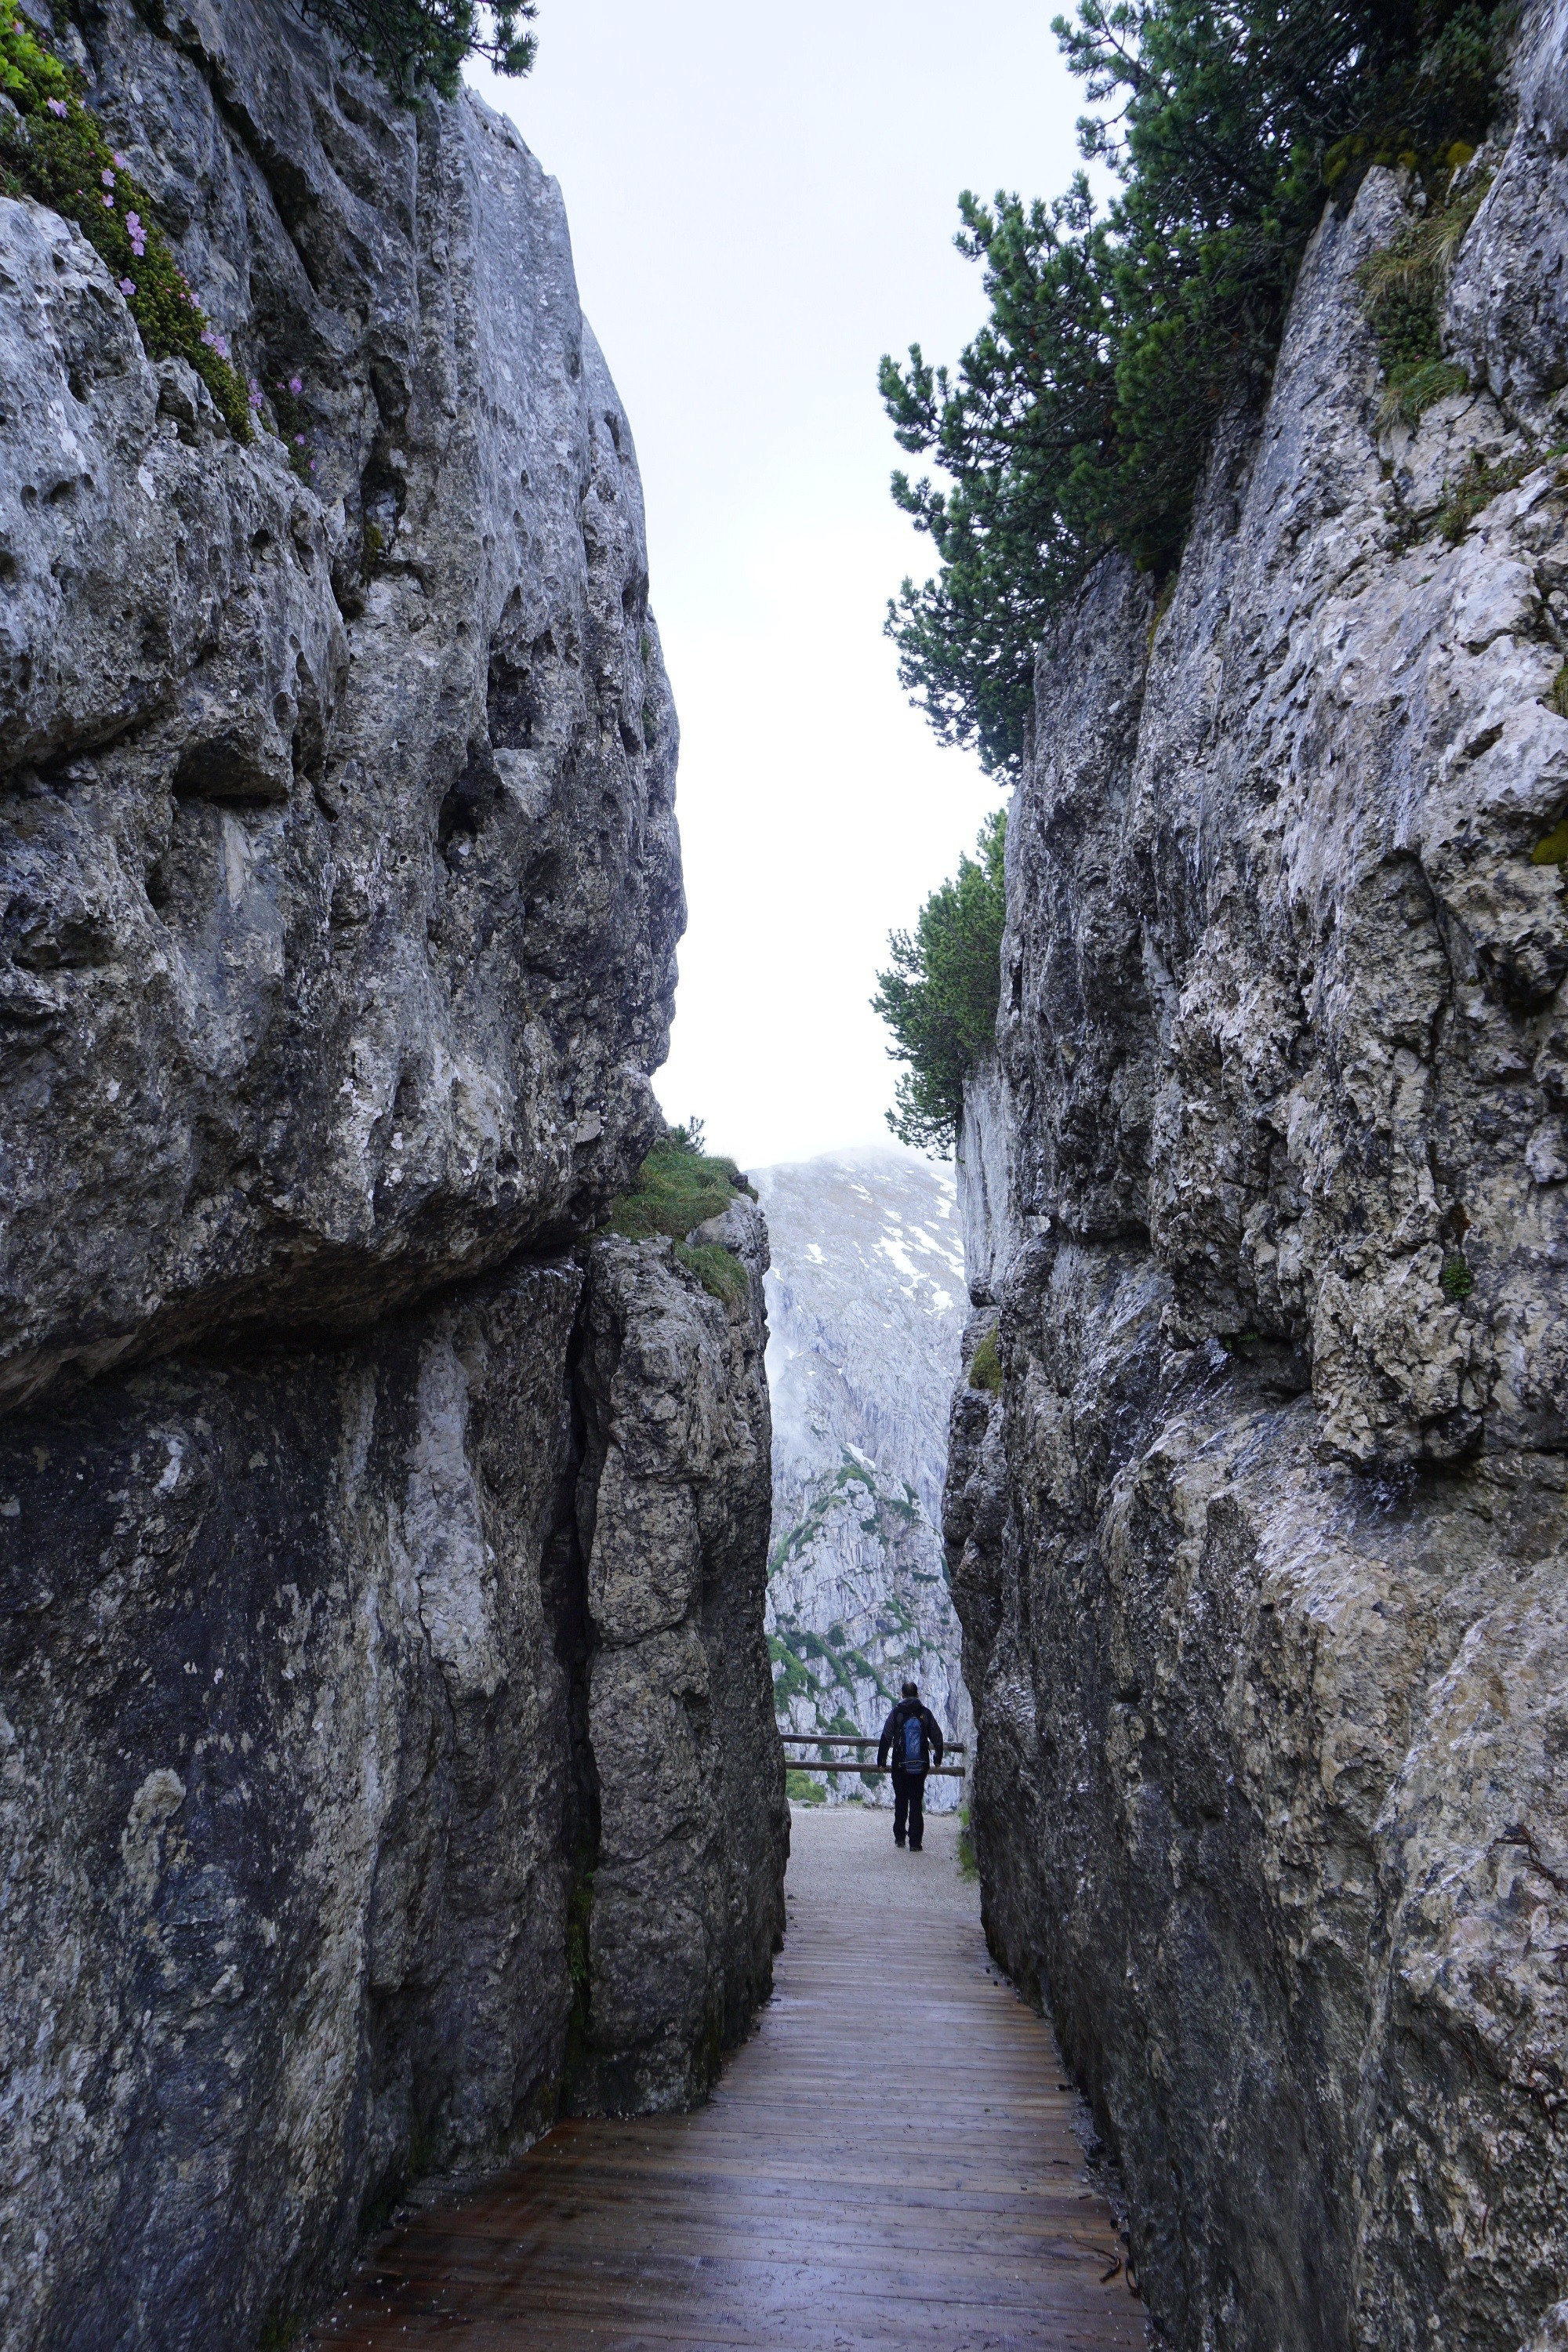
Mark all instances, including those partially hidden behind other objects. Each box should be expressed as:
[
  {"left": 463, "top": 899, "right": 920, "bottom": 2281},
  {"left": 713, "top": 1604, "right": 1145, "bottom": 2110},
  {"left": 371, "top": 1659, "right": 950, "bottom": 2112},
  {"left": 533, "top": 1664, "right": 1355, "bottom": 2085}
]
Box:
[{"left": 572, "top": 1200, "right": 789, "bottom": 2114}]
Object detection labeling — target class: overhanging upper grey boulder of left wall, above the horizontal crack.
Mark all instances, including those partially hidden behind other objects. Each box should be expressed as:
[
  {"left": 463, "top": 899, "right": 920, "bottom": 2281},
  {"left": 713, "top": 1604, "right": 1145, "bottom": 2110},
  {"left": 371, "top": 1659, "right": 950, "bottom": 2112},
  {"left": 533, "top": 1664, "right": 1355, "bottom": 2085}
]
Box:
[{"left": 0, "top": 0, "right": 684, "bottom": 1397}]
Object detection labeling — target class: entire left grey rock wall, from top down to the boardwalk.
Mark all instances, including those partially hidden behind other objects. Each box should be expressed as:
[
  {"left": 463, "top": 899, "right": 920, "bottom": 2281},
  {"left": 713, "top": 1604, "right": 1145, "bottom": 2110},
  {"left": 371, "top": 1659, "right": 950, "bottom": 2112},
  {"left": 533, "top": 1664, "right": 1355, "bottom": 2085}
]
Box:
[{"left": 0, "top": 0, "right": 787, "bottom": 2352}]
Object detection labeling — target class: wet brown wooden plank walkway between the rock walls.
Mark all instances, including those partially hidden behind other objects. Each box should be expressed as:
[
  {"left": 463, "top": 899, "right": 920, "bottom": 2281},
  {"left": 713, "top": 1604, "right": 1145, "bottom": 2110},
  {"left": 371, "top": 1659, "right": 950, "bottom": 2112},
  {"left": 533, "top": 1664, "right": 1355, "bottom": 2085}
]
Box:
[{"left": 313, "top": 1806, "right": 1145, "bottom": 2352}]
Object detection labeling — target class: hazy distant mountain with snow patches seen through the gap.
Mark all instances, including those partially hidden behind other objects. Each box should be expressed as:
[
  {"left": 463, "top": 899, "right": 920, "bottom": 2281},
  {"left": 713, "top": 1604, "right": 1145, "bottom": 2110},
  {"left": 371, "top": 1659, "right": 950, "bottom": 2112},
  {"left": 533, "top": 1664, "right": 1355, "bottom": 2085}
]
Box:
[{"left": 753, "top": 1148, "right": 973, "bottom": 1806}]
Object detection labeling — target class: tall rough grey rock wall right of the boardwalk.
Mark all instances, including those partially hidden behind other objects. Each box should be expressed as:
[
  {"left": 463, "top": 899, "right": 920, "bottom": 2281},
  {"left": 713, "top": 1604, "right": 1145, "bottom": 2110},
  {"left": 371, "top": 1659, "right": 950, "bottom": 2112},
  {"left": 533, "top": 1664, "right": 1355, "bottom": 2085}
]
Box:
[{"left": 945, "top": 7, "right": 1568, "bottom": 2352}]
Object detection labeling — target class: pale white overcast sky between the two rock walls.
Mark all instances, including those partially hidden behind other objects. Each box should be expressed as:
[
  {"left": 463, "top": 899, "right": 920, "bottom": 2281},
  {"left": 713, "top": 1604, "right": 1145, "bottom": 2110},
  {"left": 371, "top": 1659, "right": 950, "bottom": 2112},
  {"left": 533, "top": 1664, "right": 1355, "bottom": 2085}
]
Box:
[{"left": 475, "top": 0, "right": 1081, "bottom": 1164}]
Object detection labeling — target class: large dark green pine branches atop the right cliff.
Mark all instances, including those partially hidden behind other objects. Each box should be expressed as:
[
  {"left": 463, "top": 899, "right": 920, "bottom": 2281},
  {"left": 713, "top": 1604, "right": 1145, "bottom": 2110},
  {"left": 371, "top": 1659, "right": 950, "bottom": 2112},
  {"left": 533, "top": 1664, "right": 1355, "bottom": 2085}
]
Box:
[{"left": 879, "top": 0, "right": 1512, "bottom": 774}]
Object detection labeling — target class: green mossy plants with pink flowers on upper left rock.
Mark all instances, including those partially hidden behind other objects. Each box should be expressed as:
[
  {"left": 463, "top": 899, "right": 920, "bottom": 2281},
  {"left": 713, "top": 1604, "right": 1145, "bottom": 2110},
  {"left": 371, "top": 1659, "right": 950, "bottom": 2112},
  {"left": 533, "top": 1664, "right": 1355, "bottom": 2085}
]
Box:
[{"left": 0, "top": 9, "right": 252, "bottom": 442}]
